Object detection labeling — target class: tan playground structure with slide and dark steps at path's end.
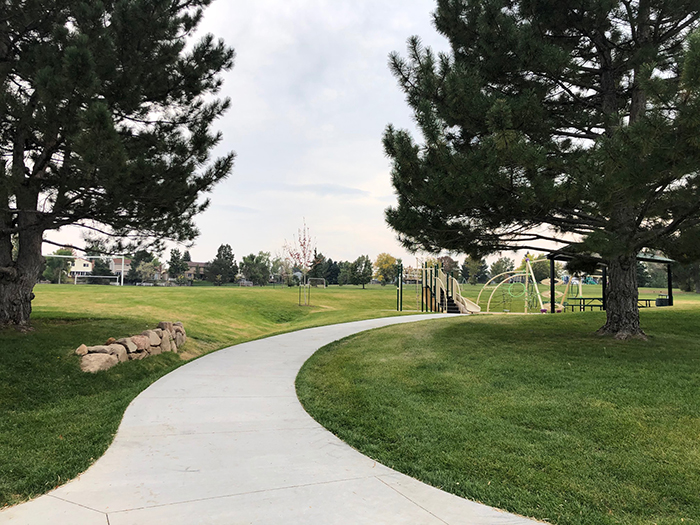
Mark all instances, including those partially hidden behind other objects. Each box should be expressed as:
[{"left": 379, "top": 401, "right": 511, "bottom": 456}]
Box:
[{"left": 396, "top": 263, "right": 481, "bottom": 314}]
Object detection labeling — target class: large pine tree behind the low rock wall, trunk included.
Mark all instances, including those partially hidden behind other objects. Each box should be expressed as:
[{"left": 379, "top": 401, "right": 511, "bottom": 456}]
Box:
[{"left": 0, "top": 0, "right": 234, "bottom": 325}]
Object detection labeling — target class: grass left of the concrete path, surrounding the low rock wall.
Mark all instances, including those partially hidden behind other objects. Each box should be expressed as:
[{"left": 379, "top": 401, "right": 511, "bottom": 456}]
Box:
[{"left": 0, "top": 285, "right": 396, "bottom": 507}]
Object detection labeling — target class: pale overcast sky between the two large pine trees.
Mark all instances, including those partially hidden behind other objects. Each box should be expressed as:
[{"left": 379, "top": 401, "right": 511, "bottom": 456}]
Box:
[{"left": 46, "top": 0, "right": 478, "bottom": 263}]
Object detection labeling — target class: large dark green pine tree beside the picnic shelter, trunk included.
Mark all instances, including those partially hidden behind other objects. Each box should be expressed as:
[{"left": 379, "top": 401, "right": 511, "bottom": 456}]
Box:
[{"left": 384, "top": 0, "right": 700, "bottom": 339}]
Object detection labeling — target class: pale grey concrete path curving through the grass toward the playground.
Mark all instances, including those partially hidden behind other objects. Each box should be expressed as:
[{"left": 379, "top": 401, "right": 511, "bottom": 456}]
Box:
[{"left": 0, "top": 315, "right": 536, "bottom": 525}]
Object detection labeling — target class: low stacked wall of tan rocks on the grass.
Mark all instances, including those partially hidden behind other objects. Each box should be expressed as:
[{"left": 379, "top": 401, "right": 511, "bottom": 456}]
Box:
[{"left": 75, "top": 322, "right": 187, "bottom": 372}]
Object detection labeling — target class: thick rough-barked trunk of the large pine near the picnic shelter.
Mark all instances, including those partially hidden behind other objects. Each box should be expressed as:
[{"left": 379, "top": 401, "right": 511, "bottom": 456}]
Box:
[{"left": 598, "top": 255, "right": 646, "bottom": 339}]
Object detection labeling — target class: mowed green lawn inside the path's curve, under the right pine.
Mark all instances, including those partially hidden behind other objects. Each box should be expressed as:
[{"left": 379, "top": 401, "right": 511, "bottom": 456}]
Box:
[{"left": 297, "top": 304, "right": 700, "bottom": 525}]
